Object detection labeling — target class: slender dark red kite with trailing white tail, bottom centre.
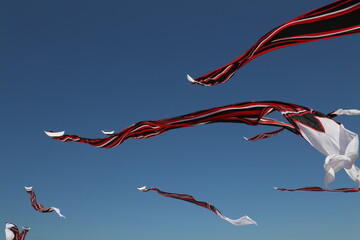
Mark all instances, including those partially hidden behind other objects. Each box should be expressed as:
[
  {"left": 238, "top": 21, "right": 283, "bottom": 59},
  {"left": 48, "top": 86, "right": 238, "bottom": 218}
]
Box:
[{"left": 138, "top": 186, "right": 257, "bottom": 226}]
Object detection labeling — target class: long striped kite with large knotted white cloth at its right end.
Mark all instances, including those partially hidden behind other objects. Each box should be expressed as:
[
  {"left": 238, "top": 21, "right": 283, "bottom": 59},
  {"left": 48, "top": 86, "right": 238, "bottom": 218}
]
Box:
[{"left": 46, "top": 101, "right": 360, "bottom": 186}]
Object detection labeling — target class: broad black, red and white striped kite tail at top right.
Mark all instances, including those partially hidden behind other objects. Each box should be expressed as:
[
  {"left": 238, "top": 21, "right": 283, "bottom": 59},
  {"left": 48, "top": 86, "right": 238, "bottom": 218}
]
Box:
[{"left": 187, "top": 0, "right": 360, "bottom": 86}]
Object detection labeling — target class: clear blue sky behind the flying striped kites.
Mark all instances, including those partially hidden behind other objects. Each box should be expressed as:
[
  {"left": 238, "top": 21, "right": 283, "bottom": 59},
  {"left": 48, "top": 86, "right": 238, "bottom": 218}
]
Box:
[{"left": 0, "top": 0, "right": 360, "bottom": 240}]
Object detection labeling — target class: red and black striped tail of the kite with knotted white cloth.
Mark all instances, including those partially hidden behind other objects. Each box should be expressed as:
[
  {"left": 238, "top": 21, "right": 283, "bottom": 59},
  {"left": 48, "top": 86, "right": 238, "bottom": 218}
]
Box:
[{"left": 46, "top": 101, "right": 326, "bottom": 148}]
